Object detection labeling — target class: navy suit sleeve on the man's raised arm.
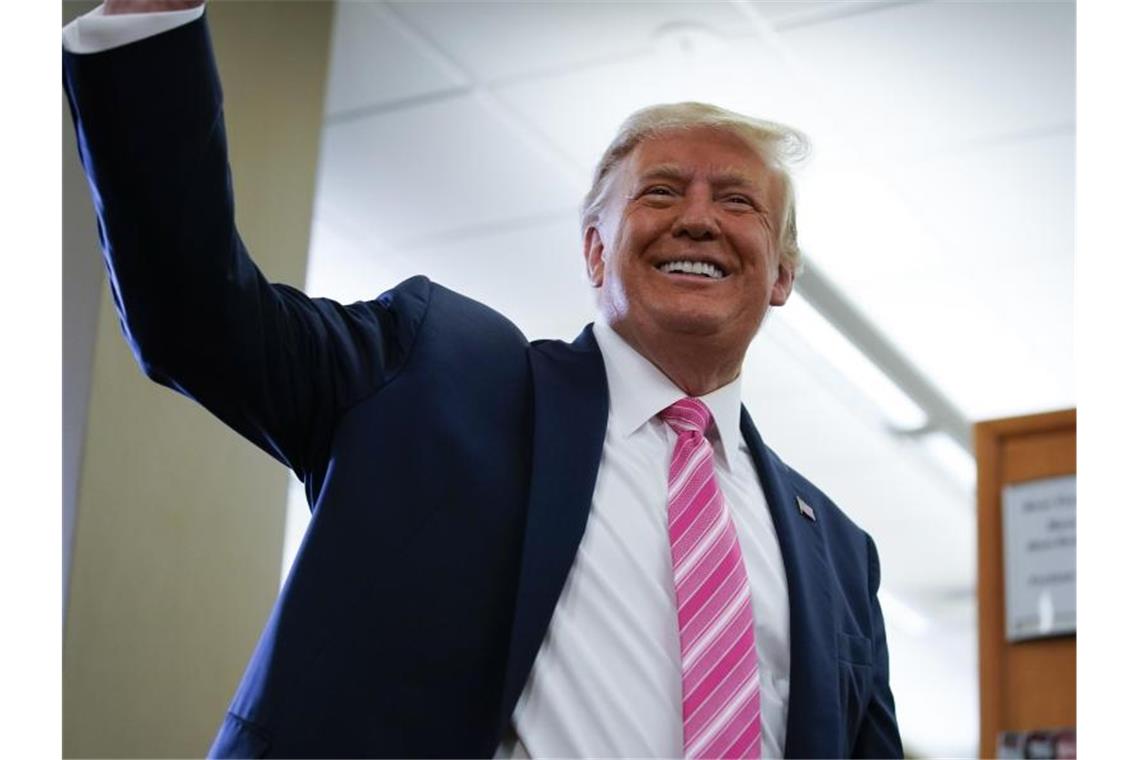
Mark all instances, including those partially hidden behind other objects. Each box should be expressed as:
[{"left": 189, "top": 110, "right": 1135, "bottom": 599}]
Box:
[{"left": 64, "top": 17, "right": 429, "bottom": 477}]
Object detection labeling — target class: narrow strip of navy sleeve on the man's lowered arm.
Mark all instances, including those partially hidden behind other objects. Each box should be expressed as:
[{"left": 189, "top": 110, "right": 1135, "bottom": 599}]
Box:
[{"left": 852, "top": 536, "right": 903, "bottom": 758}]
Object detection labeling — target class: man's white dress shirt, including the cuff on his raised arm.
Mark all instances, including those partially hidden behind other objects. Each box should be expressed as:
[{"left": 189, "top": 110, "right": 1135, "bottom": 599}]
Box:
[{"left": 63, "top": 6, "right": 790, "bottom": 758}]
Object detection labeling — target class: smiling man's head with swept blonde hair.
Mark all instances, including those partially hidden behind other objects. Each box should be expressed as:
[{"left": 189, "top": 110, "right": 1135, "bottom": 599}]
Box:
[{"left": 584, "top": 121, "right": 801, "bottom": 395}]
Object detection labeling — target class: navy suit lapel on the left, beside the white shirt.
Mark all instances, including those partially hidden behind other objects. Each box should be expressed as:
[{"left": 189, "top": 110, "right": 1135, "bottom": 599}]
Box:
[{"left": 496, "top": 326, "right": 610, "bottom": 736}]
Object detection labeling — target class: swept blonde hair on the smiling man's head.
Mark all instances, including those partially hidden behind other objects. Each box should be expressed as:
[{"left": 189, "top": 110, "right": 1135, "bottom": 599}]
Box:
[{"left": 580, "top": 101, "right": 808, "bottom": 271}]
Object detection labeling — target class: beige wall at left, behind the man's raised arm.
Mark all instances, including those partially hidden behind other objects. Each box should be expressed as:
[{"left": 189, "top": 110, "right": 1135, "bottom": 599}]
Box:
[{"left": 63, "top": 0, "right": 334, "bottom": 757}]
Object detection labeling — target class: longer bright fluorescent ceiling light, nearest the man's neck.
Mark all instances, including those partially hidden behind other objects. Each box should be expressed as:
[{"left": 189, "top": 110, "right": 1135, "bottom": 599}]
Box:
[{"left": 777, "top": 297, "right": 927, "bottom": 431}]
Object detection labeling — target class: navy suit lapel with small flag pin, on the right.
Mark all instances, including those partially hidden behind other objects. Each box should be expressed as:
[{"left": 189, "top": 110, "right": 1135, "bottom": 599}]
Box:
[{"left": 740, "top": 408, "right": 842, "bottom": 758}]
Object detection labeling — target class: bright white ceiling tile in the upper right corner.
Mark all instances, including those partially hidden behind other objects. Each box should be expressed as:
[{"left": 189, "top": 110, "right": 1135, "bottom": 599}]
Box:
[{"left": 781, "top": 2, "right": 1075, "bottom": 161}]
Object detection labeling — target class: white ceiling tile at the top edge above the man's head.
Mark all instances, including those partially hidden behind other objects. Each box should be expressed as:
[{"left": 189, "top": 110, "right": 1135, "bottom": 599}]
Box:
[{"left": 391, "top": 2, "right": 747, "bottom": 82}]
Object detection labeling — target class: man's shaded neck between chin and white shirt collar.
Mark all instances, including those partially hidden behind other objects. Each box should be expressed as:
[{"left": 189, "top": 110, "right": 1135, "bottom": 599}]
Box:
[{"left": 610, "top": 325, "right": 744, "bottom": 397}]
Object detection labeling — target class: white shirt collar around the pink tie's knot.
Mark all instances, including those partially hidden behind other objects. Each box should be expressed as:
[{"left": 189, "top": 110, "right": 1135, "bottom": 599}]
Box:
[{"left": 594, "top": 319, "right": 741, "bottom": 471}]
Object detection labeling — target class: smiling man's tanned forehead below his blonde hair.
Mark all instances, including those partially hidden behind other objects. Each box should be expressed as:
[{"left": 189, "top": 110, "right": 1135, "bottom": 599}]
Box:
[{"left": 625, "top": 126, "right": 773, "bottom": 187}]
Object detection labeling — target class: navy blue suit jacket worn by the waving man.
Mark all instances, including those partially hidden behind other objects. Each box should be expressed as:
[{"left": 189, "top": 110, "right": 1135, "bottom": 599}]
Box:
[{"left": 64, "top": 13, "right": 902, "bottom": 757}]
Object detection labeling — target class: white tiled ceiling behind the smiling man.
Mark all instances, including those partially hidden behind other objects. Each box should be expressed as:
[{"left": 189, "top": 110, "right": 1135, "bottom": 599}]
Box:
[{"left": 280, "top": 0, "right": 1075, "bottom": 755}]
